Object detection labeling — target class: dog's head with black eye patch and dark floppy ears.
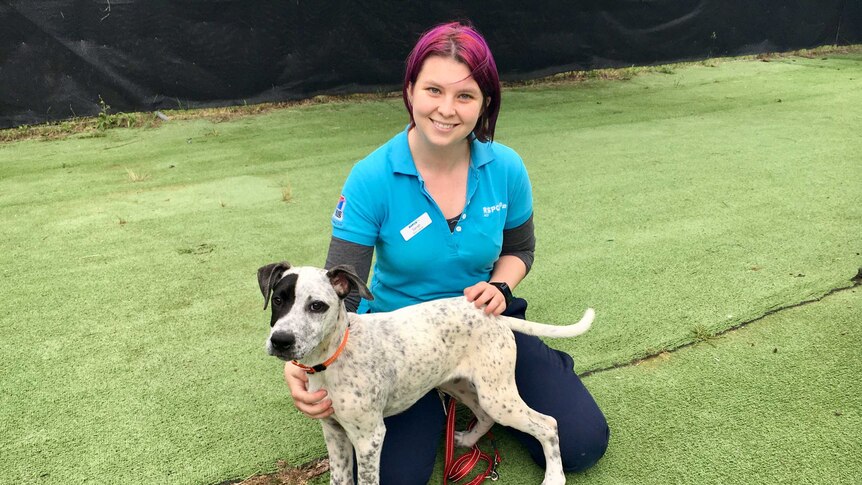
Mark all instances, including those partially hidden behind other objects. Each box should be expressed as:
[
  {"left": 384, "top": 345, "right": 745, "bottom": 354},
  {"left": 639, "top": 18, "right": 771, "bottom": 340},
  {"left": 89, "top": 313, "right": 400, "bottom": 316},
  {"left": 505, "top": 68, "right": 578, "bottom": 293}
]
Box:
[{"left": 257, "top": 262, "right": 374, "bottom": 360}]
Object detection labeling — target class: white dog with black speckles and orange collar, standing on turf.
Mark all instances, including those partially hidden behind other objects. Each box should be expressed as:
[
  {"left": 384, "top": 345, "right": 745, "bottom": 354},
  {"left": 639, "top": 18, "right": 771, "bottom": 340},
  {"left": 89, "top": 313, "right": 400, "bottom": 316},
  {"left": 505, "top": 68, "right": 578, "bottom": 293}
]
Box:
[{"left": 258, "top": 262, "right": 594, "bottom": 485}]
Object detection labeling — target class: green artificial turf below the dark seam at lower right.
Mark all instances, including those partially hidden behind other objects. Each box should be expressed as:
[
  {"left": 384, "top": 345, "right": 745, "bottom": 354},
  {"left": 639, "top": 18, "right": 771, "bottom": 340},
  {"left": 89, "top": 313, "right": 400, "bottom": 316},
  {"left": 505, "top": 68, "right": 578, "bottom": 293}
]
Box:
[{"left": 426, "top": 288, "right": 862, "bottom": 485}]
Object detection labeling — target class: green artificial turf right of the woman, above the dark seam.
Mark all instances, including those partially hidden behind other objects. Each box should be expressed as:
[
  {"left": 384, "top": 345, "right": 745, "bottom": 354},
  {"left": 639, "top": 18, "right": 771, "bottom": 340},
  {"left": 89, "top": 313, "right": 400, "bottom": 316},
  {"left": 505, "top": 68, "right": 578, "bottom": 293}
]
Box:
[{"left": 500, "top": 53, "right": 862, "bottom": 369}]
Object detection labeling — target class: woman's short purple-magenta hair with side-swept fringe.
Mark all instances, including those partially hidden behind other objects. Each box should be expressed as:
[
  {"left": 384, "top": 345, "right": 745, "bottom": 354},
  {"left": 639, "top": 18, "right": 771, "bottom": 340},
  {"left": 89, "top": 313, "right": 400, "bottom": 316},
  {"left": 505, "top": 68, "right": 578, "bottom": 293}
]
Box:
[{"left": 402, "top": 22, "right": 500, "bottom": 142}]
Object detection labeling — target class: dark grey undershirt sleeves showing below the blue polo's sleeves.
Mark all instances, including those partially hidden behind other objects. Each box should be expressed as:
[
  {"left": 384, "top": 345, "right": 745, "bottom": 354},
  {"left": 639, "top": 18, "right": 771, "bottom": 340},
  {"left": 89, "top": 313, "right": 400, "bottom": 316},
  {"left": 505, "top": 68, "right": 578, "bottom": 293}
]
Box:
[{"left": 326, "top": 214, "right": 536, "bottom": 312}]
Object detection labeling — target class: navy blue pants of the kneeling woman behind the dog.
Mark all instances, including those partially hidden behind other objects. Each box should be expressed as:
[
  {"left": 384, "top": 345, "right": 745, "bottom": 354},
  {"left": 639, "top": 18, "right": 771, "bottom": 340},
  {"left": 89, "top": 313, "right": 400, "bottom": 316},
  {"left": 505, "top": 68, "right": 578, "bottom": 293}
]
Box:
[{"left": 356, "top": 298, "right": 610, "bottom": 485}]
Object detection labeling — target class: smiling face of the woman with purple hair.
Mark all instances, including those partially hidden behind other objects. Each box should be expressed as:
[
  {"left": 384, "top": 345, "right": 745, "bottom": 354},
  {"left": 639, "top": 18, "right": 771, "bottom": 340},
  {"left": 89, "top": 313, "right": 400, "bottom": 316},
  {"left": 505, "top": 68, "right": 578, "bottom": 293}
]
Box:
[{"left": 408, "top": 56, "right": 484, "bottom": 148}]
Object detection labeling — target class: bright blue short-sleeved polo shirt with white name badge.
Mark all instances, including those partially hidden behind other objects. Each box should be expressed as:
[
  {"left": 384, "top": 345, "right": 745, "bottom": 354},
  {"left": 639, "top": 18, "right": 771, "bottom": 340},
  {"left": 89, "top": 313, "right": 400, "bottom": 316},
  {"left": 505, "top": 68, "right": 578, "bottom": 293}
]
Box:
[{"left": 332, "top": 130, "right": 533, "bottom": 313}]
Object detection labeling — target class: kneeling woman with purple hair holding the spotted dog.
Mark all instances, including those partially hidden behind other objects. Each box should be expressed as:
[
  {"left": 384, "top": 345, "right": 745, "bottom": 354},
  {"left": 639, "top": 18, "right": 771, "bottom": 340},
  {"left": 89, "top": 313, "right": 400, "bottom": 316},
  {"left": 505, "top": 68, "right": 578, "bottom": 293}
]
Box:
[{"left": 285, "top": 23, "right": 609, "bottom": 485}]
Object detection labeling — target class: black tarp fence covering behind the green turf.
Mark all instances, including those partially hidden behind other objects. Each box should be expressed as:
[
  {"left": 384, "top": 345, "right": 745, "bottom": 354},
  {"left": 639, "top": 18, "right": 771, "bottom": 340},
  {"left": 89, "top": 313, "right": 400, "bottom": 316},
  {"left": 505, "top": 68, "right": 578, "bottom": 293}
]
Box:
[{"left": 0, "top": 0, "right": 862, "bottom": 128}]
